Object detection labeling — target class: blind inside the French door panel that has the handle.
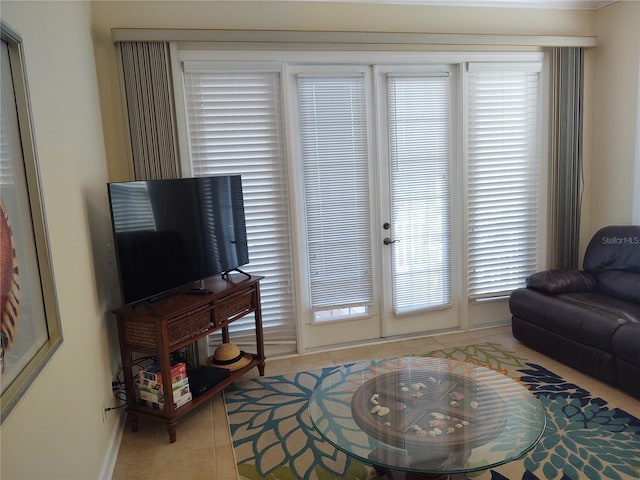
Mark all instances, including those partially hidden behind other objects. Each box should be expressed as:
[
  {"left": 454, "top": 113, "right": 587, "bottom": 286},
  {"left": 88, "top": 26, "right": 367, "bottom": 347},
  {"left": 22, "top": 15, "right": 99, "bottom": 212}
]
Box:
[{"left": 387, "top": 73, "right": 451, "bottom": 313}]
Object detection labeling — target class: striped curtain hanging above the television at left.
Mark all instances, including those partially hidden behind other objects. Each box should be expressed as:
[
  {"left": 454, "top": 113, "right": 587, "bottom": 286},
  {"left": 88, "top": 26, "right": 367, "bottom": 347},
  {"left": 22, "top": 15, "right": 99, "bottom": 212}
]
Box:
[{"left": 118, "top": 42, "right": 180, "bottom": 180}]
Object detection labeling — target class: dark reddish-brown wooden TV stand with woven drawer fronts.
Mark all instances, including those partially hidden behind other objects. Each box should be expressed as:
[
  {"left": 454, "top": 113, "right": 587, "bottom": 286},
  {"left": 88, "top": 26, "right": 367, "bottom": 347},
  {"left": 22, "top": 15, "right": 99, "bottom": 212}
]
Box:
[{"left": 115, "top": 275, "right": 265, "bottom": 443}]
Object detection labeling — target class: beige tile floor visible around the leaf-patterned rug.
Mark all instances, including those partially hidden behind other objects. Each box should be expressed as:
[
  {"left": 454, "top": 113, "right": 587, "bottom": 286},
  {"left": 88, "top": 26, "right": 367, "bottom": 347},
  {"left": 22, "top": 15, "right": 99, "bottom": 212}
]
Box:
[{"left": 113, "top": 327, "right": 640, "bottom": 480}]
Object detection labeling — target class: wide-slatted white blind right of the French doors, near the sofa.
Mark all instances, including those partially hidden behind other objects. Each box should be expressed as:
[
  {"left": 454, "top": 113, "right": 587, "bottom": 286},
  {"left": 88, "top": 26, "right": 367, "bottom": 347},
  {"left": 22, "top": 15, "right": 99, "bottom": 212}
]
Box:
[{"left": 467, "top": 64, "right": 540, "bottom": 298}]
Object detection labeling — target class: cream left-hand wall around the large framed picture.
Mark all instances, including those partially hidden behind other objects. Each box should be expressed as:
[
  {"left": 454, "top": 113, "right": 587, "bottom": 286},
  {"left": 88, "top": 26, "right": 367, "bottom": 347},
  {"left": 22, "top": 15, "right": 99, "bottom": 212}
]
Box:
[{"left": 0, "top": 0, "right": 117, "bottom": 480}]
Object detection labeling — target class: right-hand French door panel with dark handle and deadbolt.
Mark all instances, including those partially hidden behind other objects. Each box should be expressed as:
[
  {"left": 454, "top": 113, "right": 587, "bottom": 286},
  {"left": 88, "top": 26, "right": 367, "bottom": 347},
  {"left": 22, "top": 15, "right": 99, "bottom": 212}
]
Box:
[{"left": 377, "top": 66, "right": 458, "bottom": 337}]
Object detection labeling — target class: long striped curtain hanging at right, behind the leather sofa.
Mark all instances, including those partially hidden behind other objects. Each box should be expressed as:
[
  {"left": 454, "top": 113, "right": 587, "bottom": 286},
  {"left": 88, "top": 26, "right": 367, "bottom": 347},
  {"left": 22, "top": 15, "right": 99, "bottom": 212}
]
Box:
[{"left": 550, "top": 47, "right": 584, "bottom": 268}]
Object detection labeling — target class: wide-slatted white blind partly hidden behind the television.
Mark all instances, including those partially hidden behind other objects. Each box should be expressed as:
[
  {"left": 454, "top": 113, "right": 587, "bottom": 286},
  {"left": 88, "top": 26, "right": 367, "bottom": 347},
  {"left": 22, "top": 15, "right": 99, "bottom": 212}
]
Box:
[{"left": 184, "top": 69, "right": 296, "bottom": 353}]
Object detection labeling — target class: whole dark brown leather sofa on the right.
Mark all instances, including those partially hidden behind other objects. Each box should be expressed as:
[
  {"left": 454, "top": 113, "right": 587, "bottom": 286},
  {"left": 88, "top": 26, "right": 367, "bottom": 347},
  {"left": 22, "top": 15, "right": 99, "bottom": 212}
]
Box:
[{"left": 509, "top": 226, "right": 640, "bottom": 398}]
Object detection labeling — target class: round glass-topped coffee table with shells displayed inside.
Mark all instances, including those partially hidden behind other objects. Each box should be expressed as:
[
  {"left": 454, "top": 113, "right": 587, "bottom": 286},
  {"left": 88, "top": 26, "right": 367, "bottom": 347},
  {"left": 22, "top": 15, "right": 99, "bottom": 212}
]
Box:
[{"left": 309, "top": 357, "right": 545, "bottom": 480}]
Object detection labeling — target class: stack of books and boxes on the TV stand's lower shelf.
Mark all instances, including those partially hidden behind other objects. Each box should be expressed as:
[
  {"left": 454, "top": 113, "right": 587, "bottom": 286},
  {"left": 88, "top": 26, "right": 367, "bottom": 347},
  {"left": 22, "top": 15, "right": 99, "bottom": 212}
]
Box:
[{"left": 138, "top": 363, "right": 192, "bottom": 411}]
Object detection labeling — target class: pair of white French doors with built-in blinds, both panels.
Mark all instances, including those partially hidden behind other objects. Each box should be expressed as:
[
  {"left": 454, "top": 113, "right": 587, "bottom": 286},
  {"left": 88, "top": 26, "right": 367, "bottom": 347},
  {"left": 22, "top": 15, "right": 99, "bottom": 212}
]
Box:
[{"left": 292, "top": 67, "right": 458, "bottom": 348}]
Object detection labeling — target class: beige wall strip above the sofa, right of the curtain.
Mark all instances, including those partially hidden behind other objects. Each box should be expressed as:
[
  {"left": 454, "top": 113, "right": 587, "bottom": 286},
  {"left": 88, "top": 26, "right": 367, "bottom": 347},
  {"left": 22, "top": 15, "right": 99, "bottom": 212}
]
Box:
[{"left": 587, "top": 1, "right": 640, "bottom": 234}]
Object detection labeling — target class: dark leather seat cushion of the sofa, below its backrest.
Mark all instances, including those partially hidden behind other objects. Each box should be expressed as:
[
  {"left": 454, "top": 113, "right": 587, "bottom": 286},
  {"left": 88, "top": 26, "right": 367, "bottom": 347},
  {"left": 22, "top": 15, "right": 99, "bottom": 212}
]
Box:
[{"left": 509, "top": 288, "right": 640, "bottom": 352}]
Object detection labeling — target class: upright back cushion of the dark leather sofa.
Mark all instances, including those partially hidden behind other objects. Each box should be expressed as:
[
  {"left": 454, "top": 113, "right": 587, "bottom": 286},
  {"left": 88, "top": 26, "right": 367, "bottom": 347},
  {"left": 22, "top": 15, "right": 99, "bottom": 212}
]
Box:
[{"left": 584, "top": 225, "right": 640, "bottom": 274}]
